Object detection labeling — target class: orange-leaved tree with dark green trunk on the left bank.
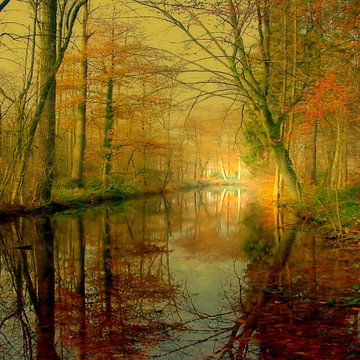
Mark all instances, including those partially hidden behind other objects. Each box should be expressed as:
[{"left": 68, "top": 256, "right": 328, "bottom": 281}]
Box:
[{"left": 88, "top": 8, "right": 172, "bottom": 187}]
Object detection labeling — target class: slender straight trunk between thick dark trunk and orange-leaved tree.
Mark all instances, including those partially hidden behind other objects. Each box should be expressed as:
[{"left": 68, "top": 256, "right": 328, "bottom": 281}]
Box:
[{"left": 71, "top": 3, "right": 89, "bottom": 187}]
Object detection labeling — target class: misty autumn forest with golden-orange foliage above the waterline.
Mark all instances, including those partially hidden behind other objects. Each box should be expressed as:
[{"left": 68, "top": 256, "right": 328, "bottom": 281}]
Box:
[{"left": 0, "top": 0, "right": 360, "bottom": 211}]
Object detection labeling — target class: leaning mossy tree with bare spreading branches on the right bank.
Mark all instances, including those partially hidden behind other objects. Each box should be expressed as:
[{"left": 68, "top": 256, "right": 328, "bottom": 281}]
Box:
[{"left": 134, "top": 0, "right": 301, "bottom": 199}]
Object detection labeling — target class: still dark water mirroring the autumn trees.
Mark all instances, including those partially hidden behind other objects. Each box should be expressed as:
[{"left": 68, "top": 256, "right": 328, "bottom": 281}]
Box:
[{"left": 0, "top": 187, "right": 360, "bottom": 360}]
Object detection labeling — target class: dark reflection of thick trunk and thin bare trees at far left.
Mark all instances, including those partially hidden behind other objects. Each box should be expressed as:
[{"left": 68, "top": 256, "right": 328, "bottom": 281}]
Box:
[{"left": 1, "top": 216, "right": 59, "bottom": 360}]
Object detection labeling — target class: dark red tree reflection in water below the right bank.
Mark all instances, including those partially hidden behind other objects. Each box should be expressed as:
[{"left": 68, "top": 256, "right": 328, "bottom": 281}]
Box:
[{"left": 211, "top": 206, "right": 360, "bottom": 359}]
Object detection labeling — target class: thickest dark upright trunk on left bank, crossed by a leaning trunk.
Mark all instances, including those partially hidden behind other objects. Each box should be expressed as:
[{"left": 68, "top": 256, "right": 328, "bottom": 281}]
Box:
[{"left": 34, "top": 0, "right": 57, "bottom": 203}]
